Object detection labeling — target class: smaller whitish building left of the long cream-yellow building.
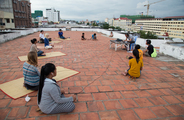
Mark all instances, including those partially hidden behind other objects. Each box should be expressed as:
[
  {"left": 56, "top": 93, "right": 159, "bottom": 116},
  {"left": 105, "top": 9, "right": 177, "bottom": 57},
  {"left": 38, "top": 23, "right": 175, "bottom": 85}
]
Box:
[{"left": 113, "top": 17, "right": 132, "bottom": 30}]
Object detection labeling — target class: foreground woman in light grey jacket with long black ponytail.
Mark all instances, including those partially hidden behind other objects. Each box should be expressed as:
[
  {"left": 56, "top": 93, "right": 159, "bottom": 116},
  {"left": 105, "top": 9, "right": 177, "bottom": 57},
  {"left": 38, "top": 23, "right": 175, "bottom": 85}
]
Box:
[{"left": 37, "top": 63, "right": 76, "bottom": 114}]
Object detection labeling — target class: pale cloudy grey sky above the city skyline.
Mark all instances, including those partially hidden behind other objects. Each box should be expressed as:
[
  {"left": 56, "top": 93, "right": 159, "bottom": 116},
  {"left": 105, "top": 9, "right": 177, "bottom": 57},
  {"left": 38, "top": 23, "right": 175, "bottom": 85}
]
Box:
[{"left": 30, "top": 0, "right": 184, "bottom": 21}]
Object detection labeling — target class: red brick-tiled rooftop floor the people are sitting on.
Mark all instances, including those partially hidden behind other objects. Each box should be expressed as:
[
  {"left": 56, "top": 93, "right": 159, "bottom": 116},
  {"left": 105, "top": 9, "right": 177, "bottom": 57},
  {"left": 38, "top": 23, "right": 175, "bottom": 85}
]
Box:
[{"left": 0, "top": 31, "right": 184, "bottom": 120}]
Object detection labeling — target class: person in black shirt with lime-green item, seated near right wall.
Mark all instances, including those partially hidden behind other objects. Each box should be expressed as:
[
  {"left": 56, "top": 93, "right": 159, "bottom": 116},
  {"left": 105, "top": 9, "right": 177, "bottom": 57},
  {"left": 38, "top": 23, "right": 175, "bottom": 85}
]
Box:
[{"left": 143, "top": 40, "right": 157, "bottom": 57}]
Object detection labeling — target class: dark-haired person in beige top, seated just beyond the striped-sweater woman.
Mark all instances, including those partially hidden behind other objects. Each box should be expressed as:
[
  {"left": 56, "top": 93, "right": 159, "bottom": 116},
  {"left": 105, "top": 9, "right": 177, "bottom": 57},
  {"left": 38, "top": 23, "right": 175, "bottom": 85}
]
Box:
[{"left": 30, "top": 38, "right": 45, "bottom": 56}]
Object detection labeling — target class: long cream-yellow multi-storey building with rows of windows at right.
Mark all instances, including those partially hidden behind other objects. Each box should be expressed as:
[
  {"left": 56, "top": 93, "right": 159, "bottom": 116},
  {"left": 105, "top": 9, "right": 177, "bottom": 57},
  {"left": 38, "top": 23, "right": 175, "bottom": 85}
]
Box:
[{"left": 132, "top": 16, "right": 184, "bottom": 39}]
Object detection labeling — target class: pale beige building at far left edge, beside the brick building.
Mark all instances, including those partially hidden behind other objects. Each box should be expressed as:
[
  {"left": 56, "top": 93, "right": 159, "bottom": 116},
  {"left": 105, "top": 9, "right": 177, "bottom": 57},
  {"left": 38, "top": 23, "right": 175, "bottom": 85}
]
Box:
[{"left": 0, "top": 0, "right": 15, "bottom": 29}]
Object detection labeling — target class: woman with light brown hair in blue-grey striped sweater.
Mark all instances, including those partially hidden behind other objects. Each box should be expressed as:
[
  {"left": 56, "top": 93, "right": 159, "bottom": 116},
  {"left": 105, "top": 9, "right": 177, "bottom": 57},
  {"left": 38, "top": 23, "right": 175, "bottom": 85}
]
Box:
[{"left": 23, "top": 51, "right": 40, "bottom": 90}]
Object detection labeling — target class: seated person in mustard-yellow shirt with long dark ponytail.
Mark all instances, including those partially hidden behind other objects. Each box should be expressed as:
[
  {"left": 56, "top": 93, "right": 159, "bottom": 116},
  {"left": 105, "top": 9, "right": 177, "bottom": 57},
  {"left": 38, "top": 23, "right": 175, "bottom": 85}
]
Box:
[{"left": 123, "top": 49, "right": 143, "bottom": 78}]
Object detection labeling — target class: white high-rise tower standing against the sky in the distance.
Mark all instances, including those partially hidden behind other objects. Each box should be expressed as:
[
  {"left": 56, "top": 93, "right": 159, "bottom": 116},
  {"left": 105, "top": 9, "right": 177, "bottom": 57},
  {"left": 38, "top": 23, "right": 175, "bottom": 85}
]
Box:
[{"left": 46, "top": 8, "right": 60, "bottom": 22}]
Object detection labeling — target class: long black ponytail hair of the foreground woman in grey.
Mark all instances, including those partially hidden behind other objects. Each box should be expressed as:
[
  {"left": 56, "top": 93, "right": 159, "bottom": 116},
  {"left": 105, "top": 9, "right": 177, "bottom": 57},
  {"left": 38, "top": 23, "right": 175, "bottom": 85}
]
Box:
[{"left": 38, "top": 63, "right": 56, "bottom": 104}]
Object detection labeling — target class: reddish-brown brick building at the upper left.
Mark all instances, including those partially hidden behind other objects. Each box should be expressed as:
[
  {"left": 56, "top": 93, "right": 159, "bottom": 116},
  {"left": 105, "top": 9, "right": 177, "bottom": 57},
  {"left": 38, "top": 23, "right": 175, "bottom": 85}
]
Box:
[{"left": 12, "top": 0, "right": 32, "bottom": 28}]
